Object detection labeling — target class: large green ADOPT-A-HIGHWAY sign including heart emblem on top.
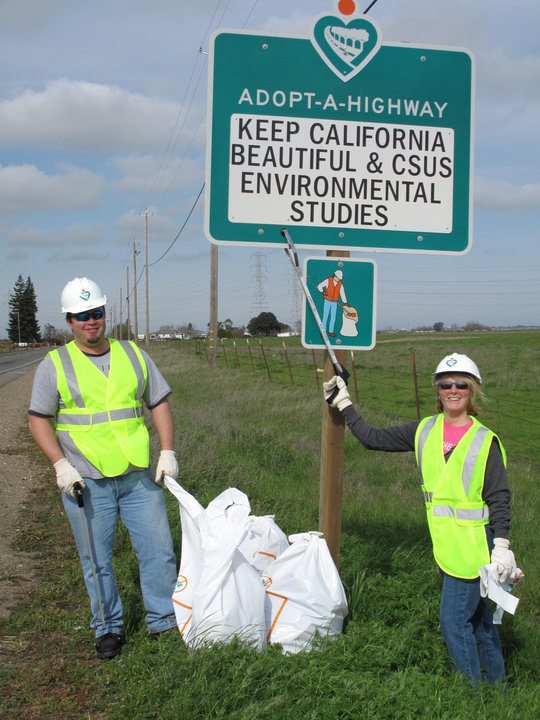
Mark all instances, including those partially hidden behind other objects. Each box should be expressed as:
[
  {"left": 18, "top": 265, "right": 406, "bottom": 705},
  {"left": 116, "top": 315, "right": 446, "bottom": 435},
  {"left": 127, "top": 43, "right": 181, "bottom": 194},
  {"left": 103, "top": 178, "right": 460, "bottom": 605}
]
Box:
[{"left": 205, "top": 4, "right": 474, "bottom": 253}]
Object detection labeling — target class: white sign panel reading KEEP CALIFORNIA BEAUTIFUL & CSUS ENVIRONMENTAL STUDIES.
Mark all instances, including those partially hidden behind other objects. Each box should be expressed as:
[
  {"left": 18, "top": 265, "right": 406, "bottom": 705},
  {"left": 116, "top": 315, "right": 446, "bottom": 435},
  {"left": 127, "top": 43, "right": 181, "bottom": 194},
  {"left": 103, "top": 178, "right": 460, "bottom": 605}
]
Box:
[{"left": 228, "top": 113, "right": 454, "bottom": 233}]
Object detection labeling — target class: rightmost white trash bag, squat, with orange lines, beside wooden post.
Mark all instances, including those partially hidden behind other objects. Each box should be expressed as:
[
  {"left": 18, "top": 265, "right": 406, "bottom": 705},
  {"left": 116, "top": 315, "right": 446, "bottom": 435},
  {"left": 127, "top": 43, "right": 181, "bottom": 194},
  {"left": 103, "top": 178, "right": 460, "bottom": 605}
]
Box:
[{"left": 263, "top": 532, "right": 348, "bottom": 653}]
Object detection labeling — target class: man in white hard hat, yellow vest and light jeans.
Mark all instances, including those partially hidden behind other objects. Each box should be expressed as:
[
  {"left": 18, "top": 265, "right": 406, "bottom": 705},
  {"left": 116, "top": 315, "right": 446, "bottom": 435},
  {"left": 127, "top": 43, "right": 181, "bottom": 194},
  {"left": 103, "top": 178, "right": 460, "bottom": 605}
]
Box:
[{"left": 29, "top": 278, "right": 178, "bottom": 659}]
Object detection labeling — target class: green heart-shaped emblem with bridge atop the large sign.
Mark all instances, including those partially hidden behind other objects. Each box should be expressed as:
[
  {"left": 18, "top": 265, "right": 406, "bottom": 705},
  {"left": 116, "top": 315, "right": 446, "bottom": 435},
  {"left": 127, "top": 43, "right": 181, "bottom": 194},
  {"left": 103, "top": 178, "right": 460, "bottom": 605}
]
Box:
[{"left": 311, "top": 15, "right": 382, "bottom": 82}]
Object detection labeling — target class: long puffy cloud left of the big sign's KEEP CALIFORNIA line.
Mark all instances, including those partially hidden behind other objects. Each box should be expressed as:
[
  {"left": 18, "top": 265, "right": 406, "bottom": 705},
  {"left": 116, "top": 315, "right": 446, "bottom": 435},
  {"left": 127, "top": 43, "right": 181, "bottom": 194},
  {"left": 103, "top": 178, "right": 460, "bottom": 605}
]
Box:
[{"left": 0, "top": 79, "right": 199, "bottom": 153}]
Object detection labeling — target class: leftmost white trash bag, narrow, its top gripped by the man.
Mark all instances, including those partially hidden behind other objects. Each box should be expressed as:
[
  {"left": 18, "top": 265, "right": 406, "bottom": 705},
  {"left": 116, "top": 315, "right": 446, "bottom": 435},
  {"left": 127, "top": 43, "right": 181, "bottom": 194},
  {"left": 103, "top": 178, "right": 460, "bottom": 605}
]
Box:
[{"left": 164, "top": 475, "right": 204, "bottom": 643}]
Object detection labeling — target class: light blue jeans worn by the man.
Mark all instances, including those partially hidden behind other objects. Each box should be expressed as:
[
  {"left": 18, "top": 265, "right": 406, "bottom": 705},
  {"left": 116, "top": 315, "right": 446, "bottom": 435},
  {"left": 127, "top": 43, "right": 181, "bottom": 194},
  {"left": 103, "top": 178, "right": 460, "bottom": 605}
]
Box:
[{"left": 62, "top": 470, "right": 176, "bottom": 637}]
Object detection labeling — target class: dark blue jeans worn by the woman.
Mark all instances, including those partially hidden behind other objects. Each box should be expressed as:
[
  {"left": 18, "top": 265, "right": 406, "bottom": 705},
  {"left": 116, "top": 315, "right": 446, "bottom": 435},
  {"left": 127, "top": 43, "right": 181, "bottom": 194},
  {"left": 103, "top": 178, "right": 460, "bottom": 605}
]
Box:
[{"left": 440, "top": 573, "right": 505, "bottom": 683}]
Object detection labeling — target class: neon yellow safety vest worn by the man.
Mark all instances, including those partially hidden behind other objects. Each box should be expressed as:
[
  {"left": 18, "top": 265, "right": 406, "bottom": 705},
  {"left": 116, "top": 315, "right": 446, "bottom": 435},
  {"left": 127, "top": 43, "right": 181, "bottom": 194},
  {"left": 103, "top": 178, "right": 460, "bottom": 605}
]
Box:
[{"left": 49, "top": 339, "right": 150, "bottom": 477}]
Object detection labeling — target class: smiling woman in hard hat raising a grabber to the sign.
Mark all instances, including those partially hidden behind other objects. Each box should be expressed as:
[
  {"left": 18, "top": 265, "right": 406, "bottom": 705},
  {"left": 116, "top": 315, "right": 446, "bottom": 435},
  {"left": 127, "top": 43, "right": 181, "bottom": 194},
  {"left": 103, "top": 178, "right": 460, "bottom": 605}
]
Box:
[{"left": 324, "top": 353, "right": 516, "bottom": 683}]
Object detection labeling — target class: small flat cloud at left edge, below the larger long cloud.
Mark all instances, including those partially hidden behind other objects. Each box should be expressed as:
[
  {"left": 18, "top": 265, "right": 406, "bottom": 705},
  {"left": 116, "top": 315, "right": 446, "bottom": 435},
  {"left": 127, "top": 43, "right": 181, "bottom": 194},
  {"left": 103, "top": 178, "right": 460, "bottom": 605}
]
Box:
[{"left": 0, "top": 165, "right": 104, "bottom": 215}]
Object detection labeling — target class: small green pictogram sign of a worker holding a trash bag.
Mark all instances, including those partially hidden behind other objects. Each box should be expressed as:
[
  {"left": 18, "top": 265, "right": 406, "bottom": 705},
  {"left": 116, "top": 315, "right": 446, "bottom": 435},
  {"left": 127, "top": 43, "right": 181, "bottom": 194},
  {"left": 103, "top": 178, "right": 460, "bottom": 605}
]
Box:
[{"left": 301, "top": 257, "right": 377, "bottom": 350}]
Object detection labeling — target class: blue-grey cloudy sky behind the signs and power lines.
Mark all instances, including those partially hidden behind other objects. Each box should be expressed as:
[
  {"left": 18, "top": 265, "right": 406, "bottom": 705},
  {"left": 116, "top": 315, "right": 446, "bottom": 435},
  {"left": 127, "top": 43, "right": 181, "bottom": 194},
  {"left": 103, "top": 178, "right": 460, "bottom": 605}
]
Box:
[{"left": 0, "top": 0, "right": 540, "bottom": 337}]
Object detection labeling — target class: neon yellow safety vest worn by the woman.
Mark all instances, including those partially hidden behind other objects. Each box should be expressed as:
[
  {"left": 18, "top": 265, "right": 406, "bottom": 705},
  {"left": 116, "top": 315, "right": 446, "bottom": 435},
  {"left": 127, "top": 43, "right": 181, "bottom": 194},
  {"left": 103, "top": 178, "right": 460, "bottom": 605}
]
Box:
[{"left": 415, "top": 414, "right": 506, "bottom": 580}]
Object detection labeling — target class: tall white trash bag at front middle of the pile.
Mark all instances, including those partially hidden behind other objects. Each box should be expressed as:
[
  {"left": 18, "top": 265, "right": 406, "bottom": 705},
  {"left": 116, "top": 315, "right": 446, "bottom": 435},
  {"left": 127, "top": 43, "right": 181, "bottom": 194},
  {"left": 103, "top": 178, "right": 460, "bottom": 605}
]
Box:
[{"left": 187, "top": 488, "right": 266, "bottom": 650}]
